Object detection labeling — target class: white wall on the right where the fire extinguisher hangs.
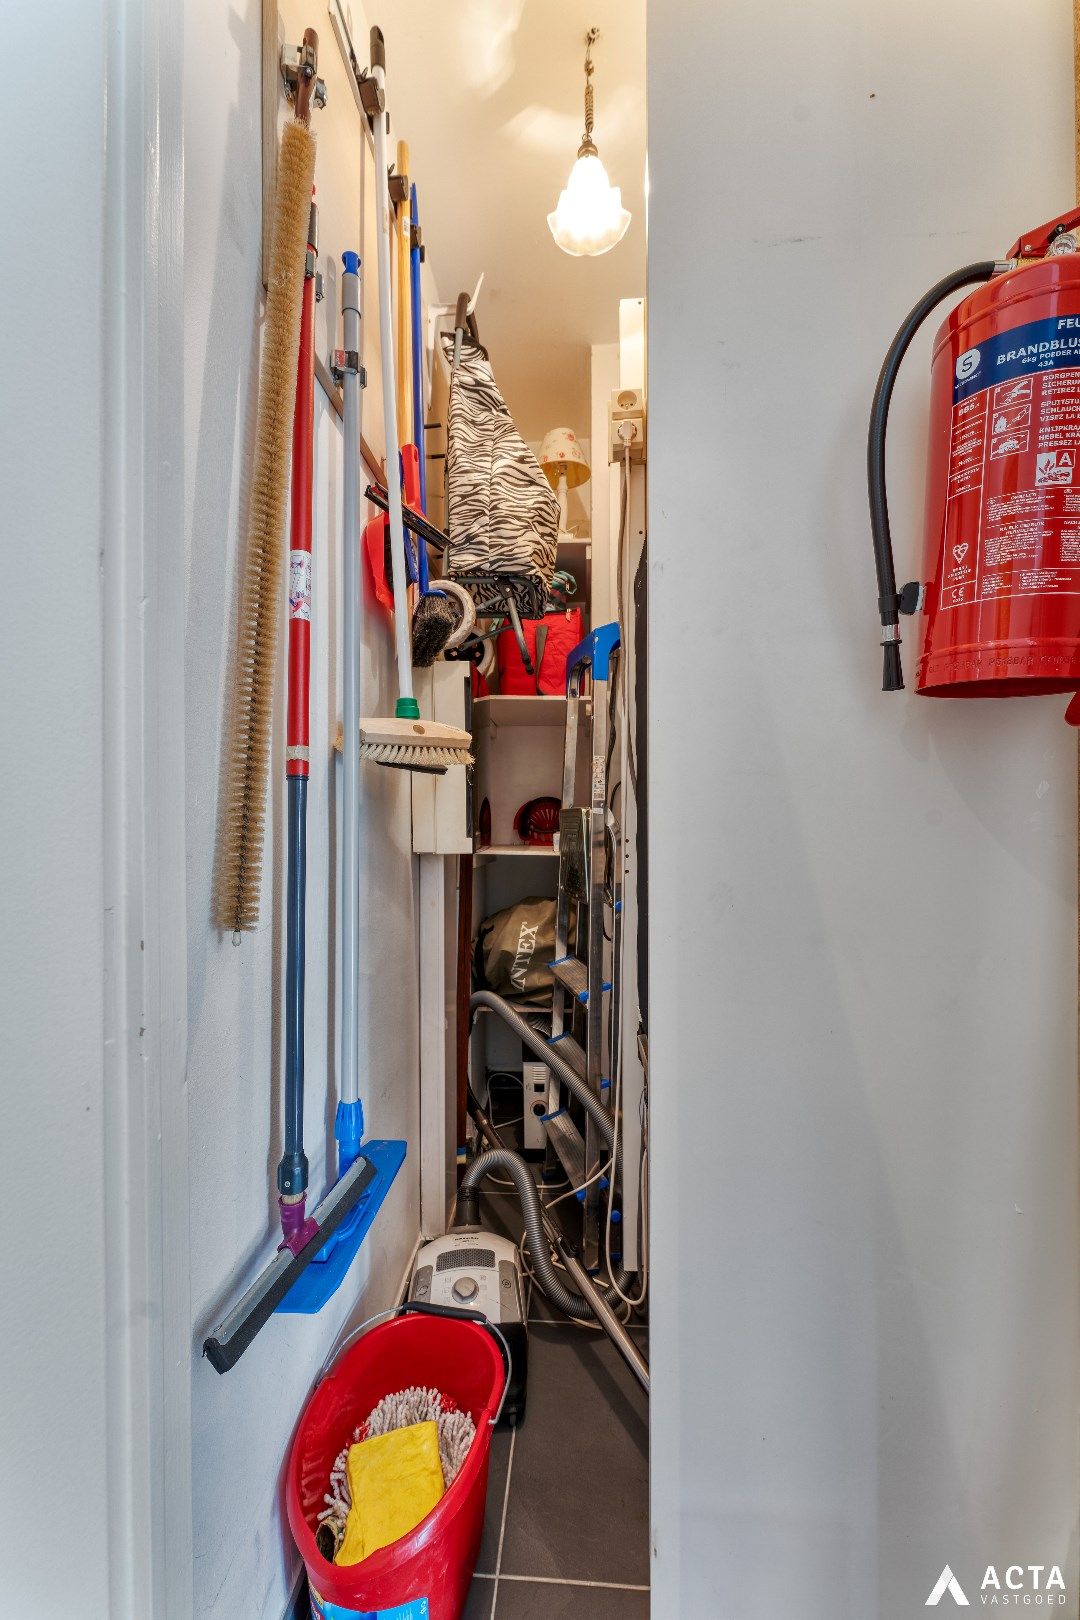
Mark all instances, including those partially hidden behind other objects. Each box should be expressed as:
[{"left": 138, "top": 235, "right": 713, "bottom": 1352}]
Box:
[{"left": 649, "top": 0, "right": 1078, "bottom": 1620}]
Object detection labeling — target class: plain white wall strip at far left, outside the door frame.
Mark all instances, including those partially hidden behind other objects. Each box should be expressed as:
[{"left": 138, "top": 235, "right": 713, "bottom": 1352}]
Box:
[{"left": 0, "top": 5, "right": 108, "bottom": 1617}]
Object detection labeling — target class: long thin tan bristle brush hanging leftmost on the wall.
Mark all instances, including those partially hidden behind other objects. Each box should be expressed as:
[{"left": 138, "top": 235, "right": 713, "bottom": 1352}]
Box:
[{"left": 214, "top": 28, "right": 319, "bottom": 938}]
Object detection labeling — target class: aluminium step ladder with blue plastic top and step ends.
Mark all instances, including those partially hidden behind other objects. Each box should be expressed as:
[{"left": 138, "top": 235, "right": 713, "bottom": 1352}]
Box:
[{"left": 544, "top": 624, "right": 622, "bottom": 1270}]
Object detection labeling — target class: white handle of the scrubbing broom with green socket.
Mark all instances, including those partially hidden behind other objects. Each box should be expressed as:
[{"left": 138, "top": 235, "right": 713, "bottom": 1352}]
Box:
[{"left": 371, "top": 28, "right": 409, "bottom": 714}]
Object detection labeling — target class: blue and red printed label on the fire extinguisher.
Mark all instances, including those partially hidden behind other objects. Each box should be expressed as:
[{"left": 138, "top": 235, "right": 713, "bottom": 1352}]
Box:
[{"left": 939, "top": 316, "right": 1080, "bottom": 611}]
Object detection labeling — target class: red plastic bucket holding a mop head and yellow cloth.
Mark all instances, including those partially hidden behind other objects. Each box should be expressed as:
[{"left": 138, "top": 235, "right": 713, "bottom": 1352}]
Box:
[{"left": 285, "top": 1314, "right": 505, "bottom": 1620}]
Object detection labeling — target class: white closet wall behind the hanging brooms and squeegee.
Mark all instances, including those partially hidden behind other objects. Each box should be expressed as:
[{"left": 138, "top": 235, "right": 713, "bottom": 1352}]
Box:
[{"left": 185, "top": 0, "right": 419, "bottom": 1620}]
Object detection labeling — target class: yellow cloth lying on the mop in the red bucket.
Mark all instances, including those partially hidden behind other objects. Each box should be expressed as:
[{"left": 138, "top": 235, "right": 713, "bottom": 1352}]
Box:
[{"left": 334, "top": 1422, "right": 445, "bottom": 1563}]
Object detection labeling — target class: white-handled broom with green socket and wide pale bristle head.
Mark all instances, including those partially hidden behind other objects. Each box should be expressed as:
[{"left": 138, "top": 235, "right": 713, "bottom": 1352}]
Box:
[{"left": 359, "top": 28, "right": 473, "bottom": 776}]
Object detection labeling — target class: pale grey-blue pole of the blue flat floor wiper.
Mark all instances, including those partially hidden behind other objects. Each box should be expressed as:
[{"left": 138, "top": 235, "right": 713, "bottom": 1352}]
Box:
[{"left": 338, "top": 253, "right": 363, "bottom": 1127}]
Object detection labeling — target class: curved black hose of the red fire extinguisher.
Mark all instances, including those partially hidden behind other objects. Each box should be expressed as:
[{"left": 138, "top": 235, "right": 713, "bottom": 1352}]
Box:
[{"left": 866, "top": 259, "right": 999, "bottom": 692}]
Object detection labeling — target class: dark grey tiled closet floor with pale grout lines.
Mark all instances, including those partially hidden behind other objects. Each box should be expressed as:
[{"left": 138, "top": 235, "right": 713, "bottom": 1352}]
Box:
[{"left": 465, "top": 1196, "right": 649, "bottom": 1620}]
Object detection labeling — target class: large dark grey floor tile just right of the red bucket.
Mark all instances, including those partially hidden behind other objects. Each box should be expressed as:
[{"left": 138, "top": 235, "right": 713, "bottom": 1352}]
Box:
[{"left": 500, "top": 1324, "right": 649, "bottom": 1586}]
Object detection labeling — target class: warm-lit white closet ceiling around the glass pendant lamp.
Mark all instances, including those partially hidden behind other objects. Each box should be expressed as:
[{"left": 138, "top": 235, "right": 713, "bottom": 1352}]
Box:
[{"left": 377, "top": 0, "right": 644, "bottom": 439}]
